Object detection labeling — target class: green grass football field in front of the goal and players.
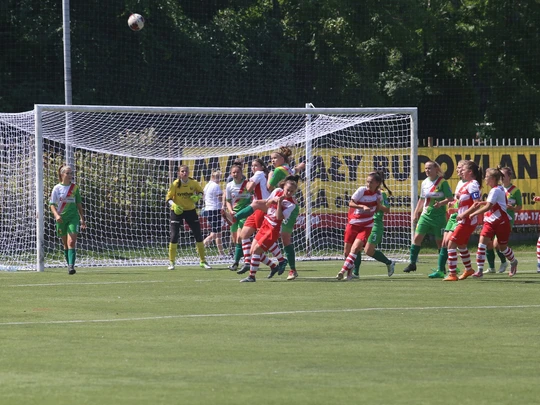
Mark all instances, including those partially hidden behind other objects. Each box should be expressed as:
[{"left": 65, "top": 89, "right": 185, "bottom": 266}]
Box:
[{"left": 0, "top": 249, "right": 540, "bottom": 405}]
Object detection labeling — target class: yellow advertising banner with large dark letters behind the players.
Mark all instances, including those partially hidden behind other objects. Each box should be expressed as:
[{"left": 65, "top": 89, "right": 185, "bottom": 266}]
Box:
[{"left": 180, "top": 146, "right": 540, "bottom": 219}]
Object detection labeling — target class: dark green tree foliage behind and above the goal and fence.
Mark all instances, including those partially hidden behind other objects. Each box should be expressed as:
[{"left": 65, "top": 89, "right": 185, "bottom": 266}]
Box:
[{"left": 0, "top": 0, "right": 540, "bottom": 138}]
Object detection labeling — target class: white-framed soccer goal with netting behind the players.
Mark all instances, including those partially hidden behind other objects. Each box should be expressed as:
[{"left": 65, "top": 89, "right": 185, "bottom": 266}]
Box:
[{"left": 0, "top": 105, "right": 418, "bottom": 271}]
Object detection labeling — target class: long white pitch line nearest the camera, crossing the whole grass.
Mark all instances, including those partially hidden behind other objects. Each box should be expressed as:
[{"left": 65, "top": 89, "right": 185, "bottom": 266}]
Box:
[{"left": 0, "top": 304, "right": 540, "bottom": 326}]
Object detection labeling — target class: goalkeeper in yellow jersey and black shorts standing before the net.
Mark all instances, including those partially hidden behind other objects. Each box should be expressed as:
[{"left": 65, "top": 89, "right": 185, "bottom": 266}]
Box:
[{"left": 165, "top": 165, "right": 212, "bottom": 270}]
